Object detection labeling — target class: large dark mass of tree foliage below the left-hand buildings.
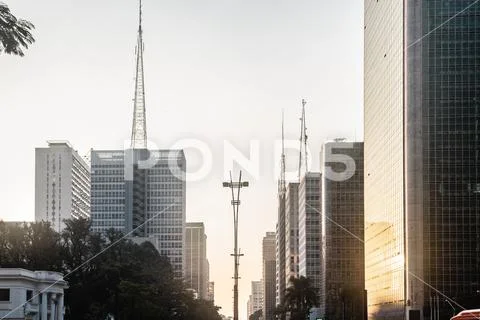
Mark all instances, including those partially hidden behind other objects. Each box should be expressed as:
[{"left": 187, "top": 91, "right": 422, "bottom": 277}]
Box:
[{"left": 0, "top": 219, "right": 221, "bottom": 320}]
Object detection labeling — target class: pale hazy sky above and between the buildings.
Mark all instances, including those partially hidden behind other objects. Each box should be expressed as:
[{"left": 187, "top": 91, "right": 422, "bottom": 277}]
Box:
[{"left": 0, "top": 0, "right": 363, "bottom": 319}]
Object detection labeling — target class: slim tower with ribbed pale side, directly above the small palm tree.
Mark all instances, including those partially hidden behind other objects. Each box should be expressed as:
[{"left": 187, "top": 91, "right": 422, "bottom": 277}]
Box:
[{"left": 298, "top": 172, "right": 323, "bottom": 302}]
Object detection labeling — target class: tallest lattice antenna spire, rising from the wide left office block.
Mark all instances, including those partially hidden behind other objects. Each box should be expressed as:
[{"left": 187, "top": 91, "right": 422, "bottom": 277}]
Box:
[{"left": 130, "top": 0, "right": 147, "bottom": 149}]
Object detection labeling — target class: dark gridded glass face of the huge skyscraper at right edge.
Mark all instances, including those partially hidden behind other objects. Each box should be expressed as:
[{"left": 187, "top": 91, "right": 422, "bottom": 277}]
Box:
[{"left": 406, "top": 0, "right": 480, "bottom": 319}]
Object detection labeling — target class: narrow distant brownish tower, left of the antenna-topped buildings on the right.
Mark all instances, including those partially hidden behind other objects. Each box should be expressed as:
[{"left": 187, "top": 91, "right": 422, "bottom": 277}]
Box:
[{"left": 262, "top": 232, "right": 276, "bottom": 320}]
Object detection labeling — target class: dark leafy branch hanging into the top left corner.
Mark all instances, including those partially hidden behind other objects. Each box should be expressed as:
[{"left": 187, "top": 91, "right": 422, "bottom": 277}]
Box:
[{"left": 0, "top": 2, "right": 35, "bottom": 57}]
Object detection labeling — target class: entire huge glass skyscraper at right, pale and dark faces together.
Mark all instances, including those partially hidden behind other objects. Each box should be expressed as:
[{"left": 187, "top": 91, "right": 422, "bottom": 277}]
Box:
[{"left": 364, "top": 0, "right": 480, "bottom": 320}]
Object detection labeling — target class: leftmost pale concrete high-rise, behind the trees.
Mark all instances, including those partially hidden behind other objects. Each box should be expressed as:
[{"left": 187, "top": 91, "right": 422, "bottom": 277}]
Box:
[{"left": 35, "top": 141, "right": 90, "bottom": 232}]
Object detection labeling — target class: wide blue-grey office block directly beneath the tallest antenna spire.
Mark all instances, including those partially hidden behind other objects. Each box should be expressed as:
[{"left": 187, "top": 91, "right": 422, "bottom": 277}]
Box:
[{"left": 91, "top": 150, "right": 186, "bottom": 277}]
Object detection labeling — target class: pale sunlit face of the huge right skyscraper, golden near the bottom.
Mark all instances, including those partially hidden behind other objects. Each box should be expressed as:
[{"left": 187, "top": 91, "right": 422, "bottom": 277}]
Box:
[{"left": 364, "top": 0, "right": 405, "bottom": 320}]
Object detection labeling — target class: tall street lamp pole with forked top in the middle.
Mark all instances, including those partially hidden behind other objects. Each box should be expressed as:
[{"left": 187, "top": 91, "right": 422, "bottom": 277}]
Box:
[{"left": 223, "top": 171, "right": 248, "bottom": 320}]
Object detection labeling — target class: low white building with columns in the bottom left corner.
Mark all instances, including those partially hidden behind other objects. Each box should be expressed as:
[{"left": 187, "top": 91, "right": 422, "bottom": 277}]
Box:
[{"left": 0, "top": 268, "right": 68, "bottom": 320}]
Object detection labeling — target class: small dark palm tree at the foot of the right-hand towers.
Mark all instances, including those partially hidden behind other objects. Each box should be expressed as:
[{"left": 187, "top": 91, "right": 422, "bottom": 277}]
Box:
[{"left": 285, "top": 276, "right": 317, "bottom": 320}]
